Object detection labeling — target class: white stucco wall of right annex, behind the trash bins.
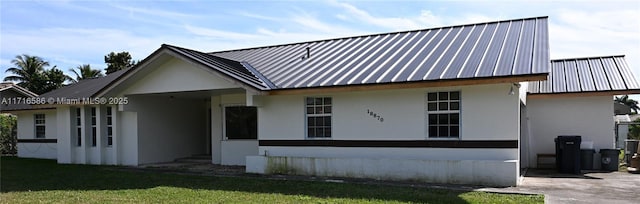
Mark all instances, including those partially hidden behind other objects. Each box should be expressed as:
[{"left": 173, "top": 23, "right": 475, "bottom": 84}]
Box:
[{"left": 527, "top": 96, "right": 615, "bottom": 167}]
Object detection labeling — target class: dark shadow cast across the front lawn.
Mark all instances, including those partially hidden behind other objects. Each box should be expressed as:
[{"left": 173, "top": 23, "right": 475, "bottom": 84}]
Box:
[{"left": 0, "top": 157, "right": 480, "bottom": 203}]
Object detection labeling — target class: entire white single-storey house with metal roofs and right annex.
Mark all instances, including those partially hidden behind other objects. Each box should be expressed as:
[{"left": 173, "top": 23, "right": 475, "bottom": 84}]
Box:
[{"left": 5, "top": 17, "right": 640, "bottom": 186}]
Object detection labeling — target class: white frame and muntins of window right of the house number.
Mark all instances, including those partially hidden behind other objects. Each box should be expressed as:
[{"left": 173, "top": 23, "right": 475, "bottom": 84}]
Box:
[{"left": 424, "top": 90, "right": 463, "bottom": 140}]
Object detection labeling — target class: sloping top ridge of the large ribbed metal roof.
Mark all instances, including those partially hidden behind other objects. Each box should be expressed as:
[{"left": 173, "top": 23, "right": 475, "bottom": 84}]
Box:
[{"left": 208, "top": 16, "right": 549, "bottom": 54}]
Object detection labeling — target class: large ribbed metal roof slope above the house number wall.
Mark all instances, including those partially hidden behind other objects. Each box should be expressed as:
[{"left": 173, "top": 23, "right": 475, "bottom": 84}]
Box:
[{"left": 210, "top": 17, "right": 549, "bottom": 89}]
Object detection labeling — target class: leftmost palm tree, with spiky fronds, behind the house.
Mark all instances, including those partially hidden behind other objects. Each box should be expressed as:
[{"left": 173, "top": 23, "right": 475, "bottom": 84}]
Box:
[{"left": 4, "top": 54, "right": 49, "bottom": 90}]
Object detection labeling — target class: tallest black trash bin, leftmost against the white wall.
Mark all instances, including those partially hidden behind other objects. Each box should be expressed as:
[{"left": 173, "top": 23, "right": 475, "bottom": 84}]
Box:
[{"left": 555, "top": 135, "right": 582, "bottom": 174}]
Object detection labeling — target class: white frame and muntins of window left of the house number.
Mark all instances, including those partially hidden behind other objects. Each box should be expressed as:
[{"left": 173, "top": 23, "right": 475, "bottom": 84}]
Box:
[{"left": 303, "top": 96, "right": 335, "bottom": 140}]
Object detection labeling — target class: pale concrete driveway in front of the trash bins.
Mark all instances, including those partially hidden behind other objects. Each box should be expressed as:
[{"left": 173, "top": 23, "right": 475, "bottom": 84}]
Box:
[{"left": 483, "top": 170, "right": 640, "bottom": 204}]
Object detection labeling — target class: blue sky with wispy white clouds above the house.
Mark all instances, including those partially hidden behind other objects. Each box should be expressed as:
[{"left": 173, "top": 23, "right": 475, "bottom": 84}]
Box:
[{"left": 0, "top": 0, "right": 640, "bottom": 89}]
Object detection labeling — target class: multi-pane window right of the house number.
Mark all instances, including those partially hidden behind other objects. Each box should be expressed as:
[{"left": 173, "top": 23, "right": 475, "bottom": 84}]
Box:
[{"left": 427, "top": 91, "right": 460, "bottom": 138}]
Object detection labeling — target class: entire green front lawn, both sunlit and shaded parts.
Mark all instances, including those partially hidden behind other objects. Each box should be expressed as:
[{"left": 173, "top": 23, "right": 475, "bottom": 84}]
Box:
[{"left": 0, "top": 157, "right": 543, "bottom": 203}]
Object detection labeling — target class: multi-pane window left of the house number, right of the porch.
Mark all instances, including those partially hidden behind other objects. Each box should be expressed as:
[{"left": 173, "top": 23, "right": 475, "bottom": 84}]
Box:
[{"left": 306, "top": 97, "right": 332, "bottom": 138}]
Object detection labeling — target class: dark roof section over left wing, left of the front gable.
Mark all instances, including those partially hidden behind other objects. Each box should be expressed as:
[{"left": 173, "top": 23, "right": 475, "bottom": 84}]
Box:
[{"left": 39, "top": 69, "right": 128, "bottom": 99}]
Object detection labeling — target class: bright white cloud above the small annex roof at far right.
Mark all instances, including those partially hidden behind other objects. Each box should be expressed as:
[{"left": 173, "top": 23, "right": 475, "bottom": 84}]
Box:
[{"left": 549, "top": 9, "right": 640, "bottom": 62}]
